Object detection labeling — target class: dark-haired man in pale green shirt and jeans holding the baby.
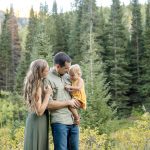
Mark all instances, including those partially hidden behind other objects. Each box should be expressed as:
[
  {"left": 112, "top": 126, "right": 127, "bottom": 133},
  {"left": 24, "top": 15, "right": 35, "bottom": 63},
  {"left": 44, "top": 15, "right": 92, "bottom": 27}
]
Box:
[{"left": 47, "top": 52, "right": 80, "bottom": 150}]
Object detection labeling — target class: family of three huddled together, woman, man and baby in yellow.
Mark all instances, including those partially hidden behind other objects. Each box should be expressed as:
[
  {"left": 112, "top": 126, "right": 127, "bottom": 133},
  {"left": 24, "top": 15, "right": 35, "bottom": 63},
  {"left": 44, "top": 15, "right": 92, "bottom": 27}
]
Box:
[{"left": 24, "top": 52, "right": 86, "bottom": 150}]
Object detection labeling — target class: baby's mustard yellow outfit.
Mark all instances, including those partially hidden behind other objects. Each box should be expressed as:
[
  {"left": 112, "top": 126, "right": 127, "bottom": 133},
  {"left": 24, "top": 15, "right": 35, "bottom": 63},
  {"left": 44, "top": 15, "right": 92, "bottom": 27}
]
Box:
[{"left": 71, "top": 80, "right": 86, "bottom": 109}]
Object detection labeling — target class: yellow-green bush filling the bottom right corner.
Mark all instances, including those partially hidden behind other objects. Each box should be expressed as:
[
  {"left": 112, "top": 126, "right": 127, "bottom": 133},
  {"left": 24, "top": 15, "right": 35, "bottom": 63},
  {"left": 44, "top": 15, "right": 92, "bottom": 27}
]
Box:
[{"left": 111, "top": 114, "right": 150, "bottom": 150}]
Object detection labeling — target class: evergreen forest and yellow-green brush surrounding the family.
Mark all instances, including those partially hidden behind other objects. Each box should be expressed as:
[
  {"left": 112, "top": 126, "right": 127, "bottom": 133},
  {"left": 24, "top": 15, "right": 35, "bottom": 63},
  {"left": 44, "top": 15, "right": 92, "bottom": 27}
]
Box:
[{"left": 0, "top": 0, "right": 150, "bottom": 150}]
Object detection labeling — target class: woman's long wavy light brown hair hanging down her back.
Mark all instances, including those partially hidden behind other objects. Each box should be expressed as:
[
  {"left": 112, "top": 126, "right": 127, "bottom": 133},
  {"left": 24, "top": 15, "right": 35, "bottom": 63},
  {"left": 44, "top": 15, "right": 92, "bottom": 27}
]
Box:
[{"left": 24, "top": 59, "right": 48, "bottom": 112}]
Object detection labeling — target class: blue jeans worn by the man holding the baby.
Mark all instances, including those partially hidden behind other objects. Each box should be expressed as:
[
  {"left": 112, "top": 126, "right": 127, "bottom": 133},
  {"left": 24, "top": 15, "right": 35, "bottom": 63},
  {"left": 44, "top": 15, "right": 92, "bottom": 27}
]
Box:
[{"left": 51, "top": 123, "right": 79, "bottom": 150}]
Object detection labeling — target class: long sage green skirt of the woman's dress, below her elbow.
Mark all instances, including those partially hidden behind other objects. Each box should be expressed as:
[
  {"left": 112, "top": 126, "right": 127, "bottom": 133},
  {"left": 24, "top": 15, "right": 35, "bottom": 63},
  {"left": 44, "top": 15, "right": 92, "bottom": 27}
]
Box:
[{"left": 24, "top": 110, "right": 49, "bottom": 150}]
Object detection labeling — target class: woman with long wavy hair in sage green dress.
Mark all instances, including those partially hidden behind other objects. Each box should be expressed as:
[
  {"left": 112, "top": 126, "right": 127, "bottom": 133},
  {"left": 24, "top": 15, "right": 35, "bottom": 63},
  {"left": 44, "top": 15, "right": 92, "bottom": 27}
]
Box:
[{"left": 24, "top": 59, "right": 52, "bottom": 150}]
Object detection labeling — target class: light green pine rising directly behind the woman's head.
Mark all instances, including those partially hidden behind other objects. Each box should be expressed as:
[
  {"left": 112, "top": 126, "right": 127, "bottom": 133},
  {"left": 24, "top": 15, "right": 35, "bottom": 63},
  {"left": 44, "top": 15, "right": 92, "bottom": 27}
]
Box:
[{"left": 31, "top": 4, "right": 52, "bottom": 65}]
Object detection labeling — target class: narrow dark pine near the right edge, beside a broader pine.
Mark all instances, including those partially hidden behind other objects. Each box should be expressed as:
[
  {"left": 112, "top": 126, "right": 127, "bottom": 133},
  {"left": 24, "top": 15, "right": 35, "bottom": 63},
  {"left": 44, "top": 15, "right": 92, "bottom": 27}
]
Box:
[{"left": 127, "top": 0, "right": 144, "bottom": 107}]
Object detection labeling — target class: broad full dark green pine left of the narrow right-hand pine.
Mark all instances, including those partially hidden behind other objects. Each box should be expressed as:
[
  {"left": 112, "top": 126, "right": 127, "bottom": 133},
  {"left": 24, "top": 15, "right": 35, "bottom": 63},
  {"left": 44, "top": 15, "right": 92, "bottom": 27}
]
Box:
[{"left": 103, "top": 0, "right": 130, "bottom": 115}]
